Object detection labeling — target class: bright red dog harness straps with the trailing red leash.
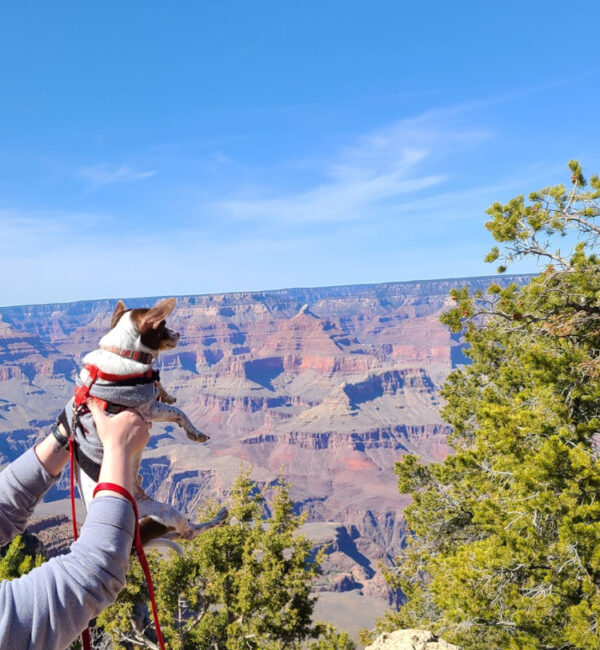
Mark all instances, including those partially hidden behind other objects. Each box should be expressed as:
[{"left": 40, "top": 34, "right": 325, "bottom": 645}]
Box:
[{"left": 69, "top": 364, "right": 165, "bottom": 650}]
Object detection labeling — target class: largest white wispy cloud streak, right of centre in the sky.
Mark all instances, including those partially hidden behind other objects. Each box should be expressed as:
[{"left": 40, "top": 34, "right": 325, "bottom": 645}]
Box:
[{"left": 211, "top": 113, "right": 491, "bottom": 224}]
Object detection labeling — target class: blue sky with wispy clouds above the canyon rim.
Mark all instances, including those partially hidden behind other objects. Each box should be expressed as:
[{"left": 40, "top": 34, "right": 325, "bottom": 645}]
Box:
[{"left": 0, "top": 0, "right": 600, "bottom": 305}]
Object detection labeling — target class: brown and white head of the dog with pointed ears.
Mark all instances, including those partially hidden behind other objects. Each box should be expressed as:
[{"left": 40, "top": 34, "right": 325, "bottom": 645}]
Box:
[{"left": 110, "top": 298, "right": 179, "bottom": 353}]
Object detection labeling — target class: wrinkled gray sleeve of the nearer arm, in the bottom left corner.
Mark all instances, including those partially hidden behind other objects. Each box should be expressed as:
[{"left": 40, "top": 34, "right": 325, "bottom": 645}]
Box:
[{"left": 0, "top": 495, "right": 135, "bottom": 650}]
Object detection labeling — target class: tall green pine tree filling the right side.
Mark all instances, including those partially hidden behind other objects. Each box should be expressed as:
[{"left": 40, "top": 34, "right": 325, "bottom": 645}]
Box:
[{"left": 368, "top": 161, "right": 600, "bottom": 650}]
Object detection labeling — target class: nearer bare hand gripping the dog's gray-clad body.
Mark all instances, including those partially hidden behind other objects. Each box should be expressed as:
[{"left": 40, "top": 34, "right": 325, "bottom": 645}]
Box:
[{"left": 86, "top": 399, "right": 152, "bottom": 456}]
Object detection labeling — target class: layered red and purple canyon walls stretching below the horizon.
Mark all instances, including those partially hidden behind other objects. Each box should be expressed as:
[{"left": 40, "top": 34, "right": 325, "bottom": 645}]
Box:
[{"left": 0, "top": 278, "right": 522, "bottom": 633}]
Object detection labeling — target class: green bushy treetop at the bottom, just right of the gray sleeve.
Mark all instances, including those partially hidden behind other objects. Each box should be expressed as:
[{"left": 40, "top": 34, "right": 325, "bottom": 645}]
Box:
[{"left": 98, "top": 472, "right": 354, "bottom": 650}]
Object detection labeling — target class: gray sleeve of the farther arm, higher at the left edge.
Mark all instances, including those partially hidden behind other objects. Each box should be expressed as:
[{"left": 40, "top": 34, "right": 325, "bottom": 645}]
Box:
[{"left": 0, "top": 447, "right": 58, "bottom": 546}]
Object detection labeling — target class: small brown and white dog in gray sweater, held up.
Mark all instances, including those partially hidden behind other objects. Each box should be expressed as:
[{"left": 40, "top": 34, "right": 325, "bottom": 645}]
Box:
[{"left": 59, "top": 298, "right": 227, "bottom": 553}]
